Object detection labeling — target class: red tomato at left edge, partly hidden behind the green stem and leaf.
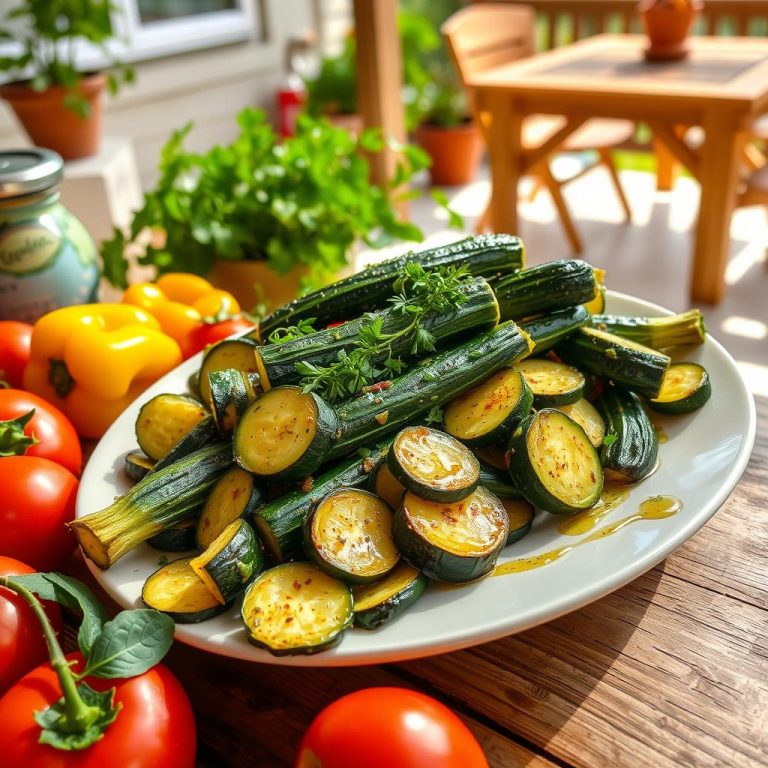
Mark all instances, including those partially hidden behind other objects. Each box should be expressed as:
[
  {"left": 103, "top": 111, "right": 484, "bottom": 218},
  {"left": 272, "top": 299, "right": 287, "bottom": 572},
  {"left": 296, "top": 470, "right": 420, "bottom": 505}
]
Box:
[{"left": 0, "top": 556, "right": 62, "bottom": 696}]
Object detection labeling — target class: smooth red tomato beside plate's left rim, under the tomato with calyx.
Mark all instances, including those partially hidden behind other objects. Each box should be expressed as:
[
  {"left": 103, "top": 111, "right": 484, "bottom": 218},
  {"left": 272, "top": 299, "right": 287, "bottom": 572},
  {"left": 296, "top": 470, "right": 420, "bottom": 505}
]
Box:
[{"left": 0, "top": 456, "right": 78, "bottom": 568}]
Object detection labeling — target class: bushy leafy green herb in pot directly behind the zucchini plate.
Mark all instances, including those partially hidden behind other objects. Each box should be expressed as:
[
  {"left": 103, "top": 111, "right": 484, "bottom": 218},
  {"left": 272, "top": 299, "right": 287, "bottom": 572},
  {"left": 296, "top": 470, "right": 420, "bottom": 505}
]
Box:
[{"left": 101, "top": 108, "right": 456, "bottom": 307}]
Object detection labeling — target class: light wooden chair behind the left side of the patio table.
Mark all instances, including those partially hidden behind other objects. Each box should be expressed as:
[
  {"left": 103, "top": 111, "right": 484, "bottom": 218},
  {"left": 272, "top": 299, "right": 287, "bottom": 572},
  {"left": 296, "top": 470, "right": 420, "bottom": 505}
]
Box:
[{"left": 441, "top": 3, "right": 634, "bottom": 253}]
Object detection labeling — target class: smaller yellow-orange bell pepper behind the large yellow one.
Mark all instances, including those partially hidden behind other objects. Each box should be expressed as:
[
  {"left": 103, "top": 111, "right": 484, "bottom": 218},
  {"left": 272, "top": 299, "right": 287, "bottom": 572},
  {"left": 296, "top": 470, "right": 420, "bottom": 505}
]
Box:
[{"left": 123, "top": 272, "right": 240, "bottom": 350}]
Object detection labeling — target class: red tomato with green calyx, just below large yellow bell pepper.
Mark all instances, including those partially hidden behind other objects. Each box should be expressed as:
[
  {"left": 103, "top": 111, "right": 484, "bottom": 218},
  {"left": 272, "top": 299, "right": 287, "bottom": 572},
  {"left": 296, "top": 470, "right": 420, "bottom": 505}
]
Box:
[{"left": 0, "top": 389, "right": 83, "bottom": 475}]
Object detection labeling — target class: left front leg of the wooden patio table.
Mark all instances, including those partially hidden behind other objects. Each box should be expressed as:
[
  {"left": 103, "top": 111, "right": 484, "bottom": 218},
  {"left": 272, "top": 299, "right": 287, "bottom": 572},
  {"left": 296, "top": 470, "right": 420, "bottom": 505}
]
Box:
[{"left": 483, "top": 92, "right": 522, "bottom": 235}]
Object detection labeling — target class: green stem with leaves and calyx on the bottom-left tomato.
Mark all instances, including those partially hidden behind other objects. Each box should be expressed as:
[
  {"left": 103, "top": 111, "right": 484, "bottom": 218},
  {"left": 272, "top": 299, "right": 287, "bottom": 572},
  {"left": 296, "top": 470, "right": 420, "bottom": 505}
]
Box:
[{"left": 0, "top": 573, "right": 174, "bottom": 751}]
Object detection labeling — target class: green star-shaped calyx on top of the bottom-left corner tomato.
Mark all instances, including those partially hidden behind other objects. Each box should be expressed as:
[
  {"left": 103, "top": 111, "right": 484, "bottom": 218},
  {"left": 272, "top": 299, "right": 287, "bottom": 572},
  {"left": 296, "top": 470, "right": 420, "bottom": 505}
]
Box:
[{"left": 35, "top": 683, "right": 122, "bottom": 751}]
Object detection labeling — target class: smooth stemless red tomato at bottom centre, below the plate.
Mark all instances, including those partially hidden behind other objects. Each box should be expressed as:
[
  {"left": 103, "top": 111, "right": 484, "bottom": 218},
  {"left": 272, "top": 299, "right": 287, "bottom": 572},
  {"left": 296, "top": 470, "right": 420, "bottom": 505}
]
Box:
[{"left": 294, "top": 688, "right": 488, "bottom": 768}]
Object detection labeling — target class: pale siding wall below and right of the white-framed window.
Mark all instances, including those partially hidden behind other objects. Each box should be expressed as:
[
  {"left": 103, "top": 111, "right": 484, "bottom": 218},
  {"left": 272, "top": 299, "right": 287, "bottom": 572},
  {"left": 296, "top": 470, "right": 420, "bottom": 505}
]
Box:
[{"left": 0, "top": 0, "right": 322, "bottom": 188}]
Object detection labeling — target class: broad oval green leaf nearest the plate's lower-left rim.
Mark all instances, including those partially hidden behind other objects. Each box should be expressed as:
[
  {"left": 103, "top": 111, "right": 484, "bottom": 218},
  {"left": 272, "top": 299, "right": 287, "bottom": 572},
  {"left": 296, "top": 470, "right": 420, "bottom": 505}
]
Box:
[{"left": 83, "top": 608, "right": 174, "bottom": 678}]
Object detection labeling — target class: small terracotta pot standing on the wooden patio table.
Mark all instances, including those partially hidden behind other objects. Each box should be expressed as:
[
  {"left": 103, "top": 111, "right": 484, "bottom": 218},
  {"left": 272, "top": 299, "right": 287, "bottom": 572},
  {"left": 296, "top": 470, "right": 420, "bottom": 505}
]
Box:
[{"left": 638, "top": 0, "right": 704, "bottom": 61}]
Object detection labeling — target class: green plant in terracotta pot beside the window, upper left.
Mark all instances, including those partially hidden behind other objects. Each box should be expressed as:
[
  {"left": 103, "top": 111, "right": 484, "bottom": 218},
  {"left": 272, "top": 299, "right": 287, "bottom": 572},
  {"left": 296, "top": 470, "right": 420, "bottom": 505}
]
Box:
[{"left": 0, "top": 0, "right": 133, "bottom": 160}]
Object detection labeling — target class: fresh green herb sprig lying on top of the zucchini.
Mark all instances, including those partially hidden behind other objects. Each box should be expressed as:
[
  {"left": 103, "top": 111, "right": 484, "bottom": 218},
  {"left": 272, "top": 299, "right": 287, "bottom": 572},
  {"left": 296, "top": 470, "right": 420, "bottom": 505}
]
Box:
[{"left": 296, "top": 262, "right": 472, "bottom": 402}]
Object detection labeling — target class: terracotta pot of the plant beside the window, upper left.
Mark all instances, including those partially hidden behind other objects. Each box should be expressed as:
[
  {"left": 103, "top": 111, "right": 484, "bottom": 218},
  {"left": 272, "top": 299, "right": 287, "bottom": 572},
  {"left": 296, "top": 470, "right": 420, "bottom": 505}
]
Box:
[{"left": 0, "top": 73, "right": 107, "bottom": 160}]
